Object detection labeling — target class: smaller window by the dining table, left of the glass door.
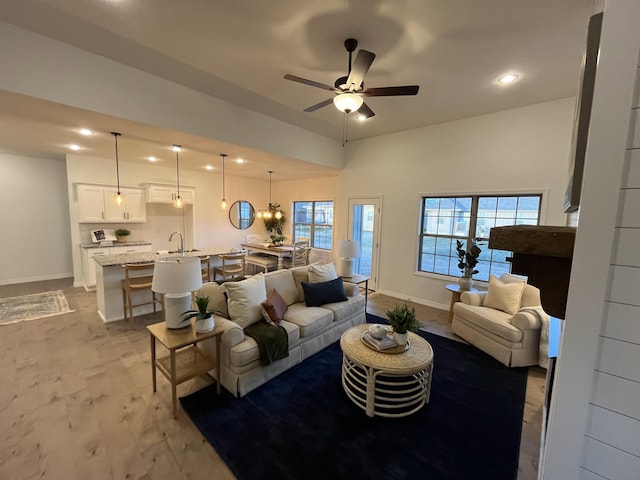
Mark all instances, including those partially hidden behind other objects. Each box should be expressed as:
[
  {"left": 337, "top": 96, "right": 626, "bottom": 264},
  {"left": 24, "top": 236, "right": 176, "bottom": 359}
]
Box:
[{"left": 293, "top": 201, "right": 333, "bottom": 250}]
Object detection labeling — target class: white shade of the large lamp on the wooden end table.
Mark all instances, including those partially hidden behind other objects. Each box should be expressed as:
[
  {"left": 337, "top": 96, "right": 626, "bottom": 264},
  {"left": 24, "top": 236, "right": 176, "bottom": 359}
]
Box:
[{"left": 151, "top": 257, "right": 202, "bottom": 293}]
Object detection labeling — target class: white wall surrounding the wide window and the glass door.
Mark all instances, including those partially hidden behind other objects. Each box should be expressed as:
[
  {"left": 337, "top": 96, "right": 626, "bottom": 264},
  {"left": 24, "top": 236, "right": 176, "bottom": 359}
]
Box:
[{"left": 336, "top": 98, "right": 575, "bottom": 307}]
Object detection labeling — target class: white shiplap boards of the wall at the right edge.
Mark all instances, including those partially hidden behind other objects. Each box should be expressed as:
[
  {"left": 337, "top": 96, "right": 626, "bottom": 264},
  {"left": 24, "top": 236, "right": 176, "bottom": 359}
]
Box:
[{"left": 582, "top": 68, "right": 640, "bottom": 479}]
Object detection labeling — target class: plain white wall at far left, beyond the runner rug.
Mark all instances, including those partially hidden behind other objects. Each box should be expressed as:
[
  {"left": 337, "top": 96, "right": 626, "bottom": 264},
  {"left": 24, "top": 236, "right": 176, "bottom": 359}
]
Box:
[{"left": 0, "top": 154, "right": 72, "bottom": 284}]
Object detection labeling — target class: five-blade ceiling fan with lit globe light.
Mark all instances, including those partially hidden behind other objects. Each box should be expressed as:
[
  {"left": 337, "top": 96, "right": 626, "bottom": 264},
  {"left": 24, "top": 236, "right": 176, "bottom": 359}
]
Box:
[{"left": 284, "top": 38, "right": 420, "bottom": 118}]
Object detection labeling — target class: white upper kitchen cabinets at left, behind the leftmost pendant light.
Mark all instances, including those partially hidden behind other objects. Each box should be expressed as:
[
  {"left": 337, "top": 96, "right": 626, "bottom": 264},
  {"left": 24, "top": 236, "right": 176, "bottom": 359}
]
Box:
[{"left": 77, "top": 184, "right": 147, "bottom": 223}]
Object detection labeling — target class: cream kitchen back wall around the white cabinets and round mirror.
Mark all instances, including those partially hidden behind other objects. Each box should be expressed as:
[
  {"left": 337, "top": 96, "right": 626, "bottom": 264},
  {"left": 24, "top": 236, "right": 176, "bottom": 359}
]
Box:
[{"left": 64, "top": 155, "right": 275, "bottom": 285}]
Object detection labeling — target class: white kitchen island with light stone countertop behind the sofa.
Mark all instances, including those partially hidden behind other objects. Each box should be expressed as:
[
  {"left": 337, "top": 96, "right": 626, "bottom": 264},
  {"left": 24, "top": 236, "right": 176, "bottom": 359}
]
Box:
[{"left": 95, "top": 248, "right": 228, "bottom": 323}]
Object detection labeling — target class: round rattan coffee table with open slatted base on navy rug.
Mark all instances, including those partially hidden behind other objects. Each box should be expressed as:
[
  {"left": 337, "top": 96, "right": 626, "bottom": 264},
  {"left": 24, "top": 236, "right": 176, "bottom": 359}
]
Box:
[{"left": 340, "top": 324, "right": 433, "bottom": 417}]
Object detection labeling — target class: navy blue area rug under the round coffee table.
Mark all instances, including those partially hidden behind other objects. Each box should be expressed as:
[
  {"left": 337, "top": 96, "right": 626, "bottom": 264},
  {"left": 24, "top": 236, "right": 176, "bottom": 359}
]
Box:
[{"left": 180, "top": 315, "right": 527, "bottom": 480}]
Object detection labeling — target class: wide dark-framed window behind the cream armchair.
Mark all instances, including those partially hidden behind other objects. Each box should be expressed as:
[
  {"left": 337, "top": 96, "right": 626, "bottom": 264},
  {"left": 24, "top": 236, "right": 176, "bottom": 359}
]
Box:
[{"left": 418, "top": 195, "right": 542, "bottom": 281}]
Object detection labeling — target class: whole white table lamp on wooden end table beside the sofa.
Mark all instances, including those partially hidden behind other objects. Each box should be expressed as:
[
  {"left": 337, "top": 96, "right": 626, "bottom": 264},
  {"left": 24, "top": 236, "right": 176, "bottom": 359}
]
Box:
[{"left": 151, "top": 257, "right": 202, "bottom": 328}]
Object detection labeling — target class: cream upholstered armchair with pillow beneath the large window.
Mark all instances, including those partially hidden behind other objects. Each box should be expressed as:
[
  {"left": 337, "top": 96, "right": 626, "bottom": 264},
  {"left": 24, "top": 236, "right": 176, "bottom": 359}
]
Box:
[{"left": 451, "top": 274, "right": 549, "bottom": 367}]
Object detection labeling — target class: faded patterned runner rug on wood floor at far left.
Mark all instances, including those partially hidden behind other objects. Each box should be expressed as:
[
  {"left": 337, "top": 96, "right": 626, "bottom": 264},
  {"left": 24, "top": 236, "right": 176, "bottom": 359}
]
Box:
[{"left": 0, "top": 290, "right": 73, "bottom": 325}]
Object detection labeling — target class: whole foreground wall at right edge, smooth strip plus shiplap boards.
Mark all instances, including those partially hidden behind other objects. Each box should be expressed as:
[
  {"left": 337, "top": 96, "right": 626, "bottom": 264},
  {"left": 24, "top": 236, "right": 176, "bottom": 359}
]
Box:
[{"left": 540, "top": 0, "right": 640, "bottom": 480}]
